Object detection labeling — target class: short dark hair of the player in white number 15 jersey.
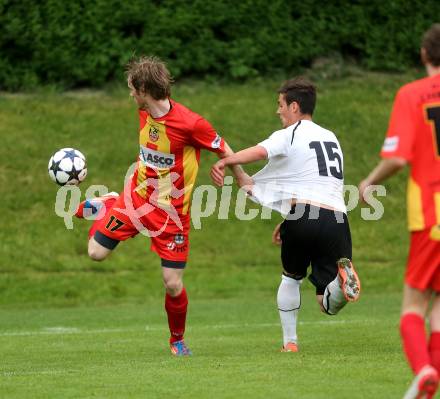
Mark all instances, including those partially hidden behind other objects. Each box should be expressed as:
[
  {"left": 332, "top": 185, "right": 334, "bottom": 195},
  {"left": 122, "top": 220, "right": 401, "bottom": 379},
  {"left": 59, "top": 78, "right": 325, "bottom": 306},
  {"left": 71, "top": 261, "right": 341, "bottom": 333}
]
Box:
[{"left": 278, "top": 76, "right": 316, "bottom": 115}]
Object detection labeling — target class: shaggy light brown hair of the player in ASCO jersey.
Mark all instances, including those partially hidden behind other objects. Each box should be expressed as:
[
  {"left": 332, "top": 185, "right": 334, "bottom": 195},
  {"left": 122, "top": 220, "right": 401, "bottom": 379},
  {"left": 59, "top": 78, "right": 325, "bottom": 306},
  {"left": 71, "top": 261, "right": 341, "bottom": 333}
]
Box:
[{"left": 126, "top": 56, "right": 173, "bottom": 100}]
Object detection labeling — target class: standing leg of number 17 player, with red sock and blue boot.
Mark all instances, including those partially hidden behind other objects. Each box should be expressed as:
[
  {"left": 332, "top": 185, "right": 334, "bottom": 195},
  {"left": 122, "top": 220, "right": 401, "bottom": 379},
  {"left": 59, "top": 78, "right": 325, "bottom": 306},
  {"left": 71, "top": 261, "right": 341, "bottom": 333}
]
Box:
[{"left": 162, "top": 259, "right": 191, "bottom": 356}]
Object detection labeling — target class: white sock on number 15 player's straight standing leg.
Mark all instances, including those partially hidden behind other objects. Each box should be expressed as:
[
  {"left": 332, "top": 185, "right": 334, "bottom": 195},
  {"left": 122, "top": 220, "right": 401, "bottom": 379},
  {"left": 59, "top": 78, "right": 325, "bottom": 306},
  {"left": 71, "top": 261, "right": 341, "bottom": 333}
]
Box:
[{"left": 277, "top": 275, "right": 302, "bottom": 345}]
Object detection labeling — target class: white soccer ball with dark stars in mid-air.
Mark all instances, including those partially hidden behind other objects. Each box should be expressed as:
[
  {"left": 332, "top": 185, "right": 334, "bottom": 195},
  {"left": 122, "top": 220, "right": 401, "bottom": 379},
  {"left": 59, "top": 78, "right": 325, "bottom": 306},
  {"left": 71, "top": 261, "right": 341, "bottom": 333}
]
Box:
[{"left": 47, "top": 148, "right": 87, "bottom": 186}]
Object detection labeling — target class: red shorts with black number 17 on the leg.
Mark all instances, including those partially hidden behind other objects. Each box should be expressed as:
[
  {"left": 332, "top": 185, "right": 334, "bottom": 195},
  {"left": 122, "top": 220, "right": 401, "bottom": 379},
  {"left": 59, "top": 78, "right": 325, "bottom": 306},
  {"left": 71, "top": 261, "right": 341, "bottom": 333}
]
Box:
[{"left": 95, "top": 193, "right": 190, "bottom": 267}]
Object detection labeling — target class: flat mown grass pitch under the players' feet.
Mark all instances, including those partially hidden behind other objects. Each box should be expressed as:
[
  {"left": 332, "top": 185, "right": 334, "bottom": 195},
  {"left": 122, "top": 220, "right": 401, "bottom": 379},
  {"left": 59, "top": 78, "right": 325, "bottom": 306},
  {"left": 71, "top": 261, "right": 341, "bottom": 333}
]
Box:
[{"left": 0, "top": 290, "right": 410, "bottom": 399}]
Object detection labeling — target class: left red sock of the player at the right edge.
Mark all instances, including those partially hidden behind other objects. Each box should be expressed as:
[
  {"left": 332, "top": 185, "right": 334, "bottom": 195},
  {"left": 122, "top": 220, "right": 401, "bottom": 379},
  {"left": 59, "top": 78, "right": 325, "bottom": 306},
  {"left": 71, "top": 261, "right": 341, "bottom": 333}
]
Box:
[{"left": 400, "top": 313, "right": 430, "bottom": 374}]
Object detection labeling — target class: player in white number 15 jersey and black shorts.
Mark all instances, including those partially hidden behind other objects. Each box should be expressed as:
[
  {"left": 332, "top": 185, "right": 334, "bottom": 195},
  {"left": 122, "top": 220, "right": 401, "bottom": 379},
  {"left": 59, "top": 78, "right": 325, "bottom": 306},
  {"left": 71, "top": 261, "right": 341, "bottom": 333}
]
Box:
[{"left": 211, "top": 78, "right": 360, "bottom": 352}]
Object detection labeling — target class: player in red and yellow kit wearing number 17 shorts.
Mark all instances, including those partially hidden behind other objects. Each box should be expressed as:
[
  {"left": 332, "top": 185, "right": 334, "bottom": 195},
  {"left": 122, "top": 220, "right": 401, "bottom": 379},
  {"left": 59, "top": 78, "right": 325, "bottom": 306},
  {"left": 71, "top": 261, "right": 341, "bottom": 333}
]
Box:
[{"left": 77, "top": 57, "right": 245, "bottom": 356}]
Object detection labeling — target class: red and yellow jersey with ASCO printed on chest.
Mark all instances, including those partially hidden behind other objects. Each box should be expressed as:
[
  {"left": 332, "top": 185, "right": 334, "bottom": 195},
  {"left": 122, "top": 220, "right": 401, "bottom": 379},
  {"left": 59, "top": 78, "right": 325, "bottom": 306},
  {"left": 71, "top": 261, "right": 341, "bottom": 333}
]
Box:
[{"left": 132, "top": 100, "right": 225, "bottom": 215}]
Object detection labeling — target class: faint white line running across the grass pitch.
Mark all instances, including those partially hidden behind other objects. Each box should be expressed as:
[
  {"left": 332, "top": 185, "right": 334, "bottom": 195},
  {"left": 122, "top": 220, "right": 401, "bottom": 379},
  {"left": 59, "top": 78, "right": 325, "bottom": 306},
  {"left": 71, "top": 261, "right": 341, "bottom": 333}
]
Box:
[{"left": 0, "top": 319, "right": 383, "bottom": 337}]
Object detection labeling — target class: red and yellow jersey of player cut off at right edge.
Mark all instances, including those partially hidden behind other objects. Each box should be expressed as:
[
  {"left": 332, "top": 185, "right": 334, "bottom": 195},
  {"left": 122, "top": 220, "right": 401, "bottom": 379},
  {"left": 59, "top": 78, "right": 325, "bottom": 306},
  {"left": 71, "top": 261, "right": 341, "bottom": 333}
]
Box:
[{"left": 381, "top": 75, "right": 440, "bottom": 231}]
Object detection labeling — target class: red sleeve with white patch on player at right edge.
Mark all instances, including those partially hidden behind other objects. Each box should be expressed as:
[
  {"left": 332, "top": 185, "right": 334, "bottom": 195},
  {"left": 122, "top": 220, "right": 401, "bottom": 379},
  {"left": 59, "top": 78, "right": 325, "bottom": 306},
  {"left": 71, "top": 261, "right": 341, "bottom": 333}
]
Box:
[{"left": 380, "top": 89, "right": 416, "bottom": 162}]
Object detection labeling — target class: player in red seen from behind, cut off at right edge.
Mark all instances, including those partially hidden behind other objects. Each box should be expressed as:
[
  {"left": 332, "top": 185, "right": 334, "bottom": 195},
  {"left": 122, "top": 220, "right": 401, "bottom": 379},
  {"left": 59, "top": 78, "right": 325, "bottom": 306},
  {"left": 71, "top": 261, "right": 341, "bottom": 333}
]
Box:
[{"left": 359, "top": 24, "right": 440, "bottom": 399}]
